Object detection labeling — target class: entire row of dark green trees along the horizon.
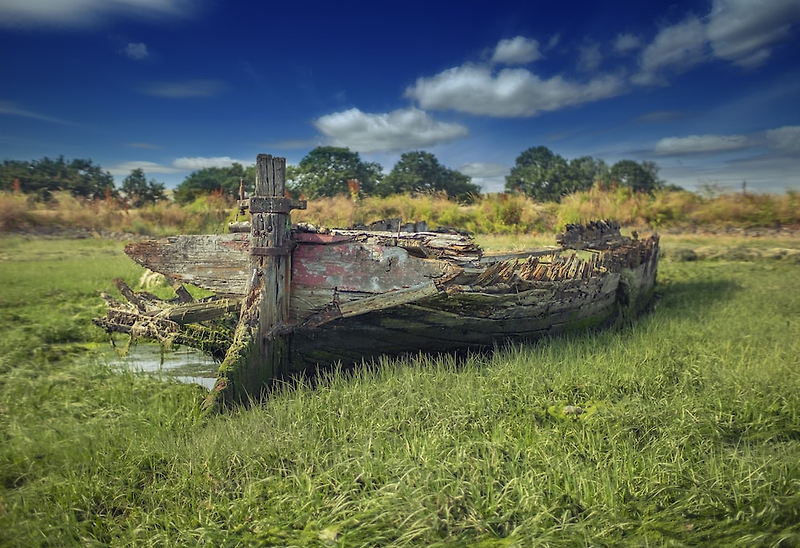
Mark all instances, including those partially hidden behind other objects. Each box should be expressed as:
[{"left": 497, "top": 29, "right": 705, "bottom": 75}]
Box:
[{"left": 0, "top": 146, "right": 664, "bottom": 207}]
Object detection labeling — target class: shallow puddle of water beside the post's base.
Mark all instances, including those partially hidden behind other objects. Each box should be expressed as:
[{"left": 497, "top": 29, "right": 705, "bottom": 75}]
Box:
[{"left": 103, "top": 343, "right": 219, "bottom": 390}]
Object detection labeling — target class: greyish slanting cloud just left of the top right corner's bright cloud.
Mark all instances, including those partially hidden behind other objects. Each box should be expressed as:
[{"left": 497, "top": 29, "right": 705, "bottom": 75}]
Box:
[{"left": 631, "top": 16, "right": 707, "bottom": 85}]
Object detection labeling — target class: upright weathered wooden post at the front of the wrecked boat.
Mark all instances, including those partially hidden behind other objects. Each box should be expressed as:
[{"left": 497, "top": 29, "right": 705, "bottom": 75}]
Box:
[{"left": 205, "top": 154, "right": 306, "bottom": 408}]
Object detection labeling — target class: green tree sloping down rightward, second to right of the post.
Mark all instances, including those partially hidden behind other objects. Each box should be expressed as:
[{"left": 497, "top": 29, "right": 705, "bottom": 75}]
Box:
[{"left": 376, "top": 150, "right": 481, "bottom": 200}]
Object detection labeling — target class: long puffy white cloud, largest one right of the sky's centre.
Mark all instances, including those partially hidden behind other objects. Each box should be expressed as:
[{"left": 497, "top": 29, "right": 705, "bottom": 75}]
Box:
[{"left": 405, "top": 65, "right": 625, "bottom": 118}]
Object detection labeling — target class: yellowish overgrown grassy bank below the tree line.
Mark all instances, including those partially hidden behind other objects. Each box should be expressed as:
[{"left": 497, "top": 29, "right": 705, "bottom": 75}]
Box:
[{"left": 0, "top": 188, "right": 800, "bottom": 236}]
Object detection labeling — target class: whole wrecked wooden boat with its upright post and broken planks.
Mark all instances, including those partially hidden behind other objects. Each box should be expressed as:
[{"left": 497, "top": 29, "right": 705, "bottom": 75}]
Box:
[{"left": 95, "top": 155, "right": 658, "bottom": 405}]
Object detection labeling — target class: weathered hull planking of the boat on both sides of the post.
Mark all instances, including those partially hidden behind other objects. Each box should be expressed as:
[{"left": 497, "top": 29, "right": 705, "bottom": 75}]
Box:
[{"left": 106, "top": 225, "right": 658, "bottom": 372}]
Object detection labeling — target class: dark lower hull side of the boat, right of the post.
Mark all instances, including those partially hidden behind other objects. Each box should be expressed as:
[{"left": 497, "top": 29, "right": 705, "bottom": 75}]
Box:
[{"left": 291, "top": 255, "right": 655, "bottom": 371}]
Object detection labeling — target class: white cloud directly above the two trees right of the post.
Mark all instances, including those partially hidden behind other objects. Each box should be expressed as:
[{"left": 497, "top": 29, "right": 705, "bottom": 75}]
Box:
[{"left": 314, "top": 107, "right": 469, "bottom": 152}]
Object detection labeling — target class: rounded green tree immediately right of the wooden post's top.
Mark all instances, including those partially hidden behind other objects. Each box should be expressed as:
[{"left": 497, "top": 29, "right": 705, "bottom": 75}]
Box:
[{"left": 286, "top": 147, "right": 383, "bottom": 198}]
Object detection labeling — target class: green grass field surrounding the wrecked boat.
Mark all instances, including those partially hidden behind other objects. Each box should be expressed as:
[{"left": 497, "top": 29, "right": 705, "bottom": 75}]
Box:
[{"left": 0, "top": 237, "right": 800, "bottom": 547}]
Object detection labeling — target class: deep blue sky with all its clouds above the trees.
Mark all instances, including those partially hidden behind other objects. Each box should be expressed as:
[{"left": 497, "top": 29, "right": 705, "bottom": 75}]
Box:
[{"left": 0, "top": 0, "right": 800, "bottom": 192}]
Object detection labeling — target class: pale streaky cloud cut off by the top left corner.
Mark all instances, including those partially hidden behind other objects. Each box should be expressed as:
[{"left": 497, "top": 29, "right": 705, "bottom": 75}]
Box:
[{"left": 0, "top": 0, "right": 198, "bottom": 28}]
